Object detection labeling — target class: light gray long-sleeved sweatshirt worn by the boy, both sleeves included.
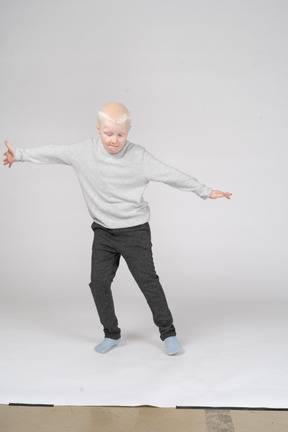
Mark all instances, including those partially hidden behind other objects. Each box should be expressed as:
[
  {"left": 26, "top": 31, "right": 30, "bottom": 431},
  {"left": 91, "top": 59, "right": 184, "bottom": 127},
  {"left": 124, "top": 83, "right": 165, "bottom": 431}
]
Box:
[{"left": 14, "top": 138, "right": 212, "bottom": 229}]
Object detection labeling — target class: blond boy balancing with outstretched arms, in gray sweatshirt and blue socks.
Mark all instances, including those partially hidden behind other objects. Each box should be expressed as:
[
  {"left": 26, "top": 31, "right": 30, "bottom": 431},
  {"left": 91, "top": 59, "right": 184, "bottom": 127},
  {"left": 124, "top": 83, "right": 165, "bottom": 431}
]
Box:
[{"left": 4, "top": 102, "right": 231, "bottom": 355}]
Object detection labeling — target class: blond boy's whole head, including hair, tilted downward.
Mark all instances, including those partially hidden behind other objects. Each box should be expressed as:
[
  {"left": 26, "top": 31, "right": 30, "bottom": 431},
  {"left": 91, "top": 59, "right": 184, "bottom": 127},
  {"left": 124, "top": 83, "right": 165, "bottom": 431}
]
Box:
[{"left": 96, "top": 102, "right": 131, "bottom": 153}]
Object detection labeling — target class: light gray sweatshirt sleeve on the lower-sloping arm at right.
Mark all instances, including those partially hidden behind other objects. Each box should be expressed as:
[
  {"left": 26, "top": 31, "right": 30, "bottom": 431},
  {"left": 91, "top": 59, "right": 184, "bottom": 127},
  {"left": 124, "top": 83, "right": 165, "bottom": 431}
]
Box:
[{"left": 143, "top": 150, "right": 212, "bottom": 199}]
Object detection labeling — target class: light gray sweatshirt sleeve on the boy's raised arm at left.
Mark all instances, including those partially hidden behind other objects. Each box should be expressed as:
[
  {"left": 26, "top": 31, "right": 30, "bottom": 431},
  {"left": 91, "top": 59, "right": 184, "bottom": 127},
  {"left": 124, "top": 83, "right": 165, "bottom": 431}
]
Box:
[{"left": 14, "top": 144, "right": 80, "bottom": 165}]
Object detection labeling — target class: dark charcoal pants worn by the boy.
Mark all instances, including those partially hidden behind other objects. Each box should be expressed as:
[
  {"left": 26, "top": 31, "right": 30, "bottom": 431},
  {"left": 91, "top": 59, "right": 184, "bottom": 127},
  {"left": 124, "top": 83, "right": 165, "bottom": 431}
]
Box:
[{"left": 89, "top": 222, "right": 176, "bottom": 340}]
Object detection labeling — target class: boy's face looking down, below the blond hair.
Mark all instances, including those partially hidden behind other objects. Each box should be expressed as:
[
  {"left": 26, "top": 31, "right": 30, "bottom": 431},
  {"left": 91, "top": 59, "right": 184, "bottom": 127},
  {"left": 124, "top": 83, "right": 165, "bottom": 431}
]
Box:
[{"left": 96, "top": 119, "right": 131, "bottom": 153}]
